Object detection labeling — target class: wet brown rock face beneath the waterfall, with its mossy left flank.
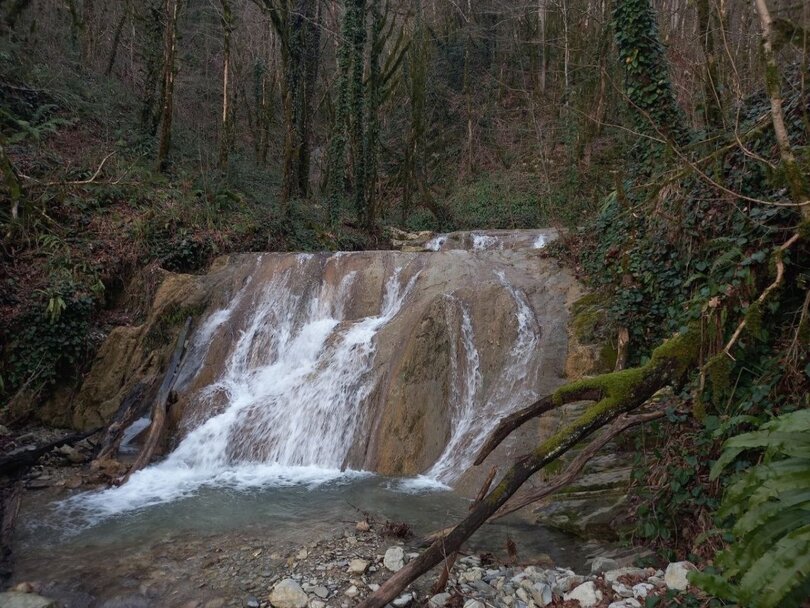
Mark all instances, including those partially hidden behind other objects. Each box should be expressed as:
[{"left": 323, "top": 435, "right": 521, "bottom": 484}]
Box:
[{"left": 63, "top": 233, "right": 580, "bottom": 487}]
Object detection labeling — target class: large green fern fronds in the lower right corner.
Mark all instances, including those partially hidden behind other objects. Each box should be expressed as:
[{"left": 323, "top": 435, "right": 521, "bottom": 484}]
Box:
[{"left": 690, "top": 410, "right": 810, "bottom": 608}]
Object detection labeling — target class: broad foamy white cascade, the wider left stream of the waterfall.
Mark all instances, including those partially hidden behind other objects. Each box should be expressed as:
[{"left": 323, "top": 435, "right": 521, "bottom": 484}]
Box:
[{"left": 65, "top": 256, "right": 418, "bottom": 518}]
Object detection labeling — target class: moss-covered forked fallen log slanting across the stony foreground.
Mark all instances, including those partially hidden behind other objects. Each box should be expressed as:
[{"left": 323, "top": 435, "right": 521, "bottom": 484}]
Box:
[{"left": 359, "top": 327, "right": 700, "bottom": 608}]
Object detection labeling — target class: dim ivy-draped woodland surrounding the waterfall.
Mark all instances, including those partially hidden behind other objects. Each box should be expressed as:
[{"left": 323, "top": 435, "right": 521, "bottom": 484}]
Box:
[{"left": 0, "top": 0, "right": 810, "bottom": 608}]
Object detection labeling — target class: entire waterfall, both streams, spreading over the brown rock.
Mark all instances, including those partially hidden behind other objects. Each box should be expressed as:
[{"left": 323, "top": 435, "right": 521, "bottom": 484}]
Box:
[{"left": 61, "top": 233, "right": 565, "bottom": 519}]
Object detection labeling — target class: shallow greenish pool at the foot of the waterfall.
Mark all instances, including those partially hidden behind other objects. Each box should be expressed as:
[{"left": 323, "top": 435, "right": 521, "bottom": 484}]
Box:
[{"left": 14, "top": 475, "right": 586, "bottom": 608}]
